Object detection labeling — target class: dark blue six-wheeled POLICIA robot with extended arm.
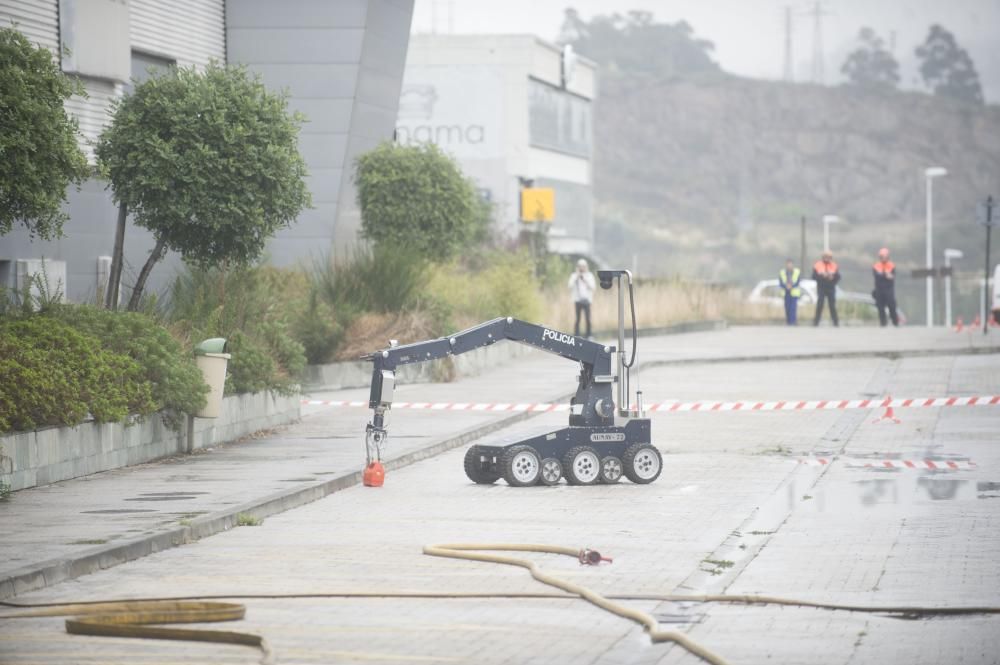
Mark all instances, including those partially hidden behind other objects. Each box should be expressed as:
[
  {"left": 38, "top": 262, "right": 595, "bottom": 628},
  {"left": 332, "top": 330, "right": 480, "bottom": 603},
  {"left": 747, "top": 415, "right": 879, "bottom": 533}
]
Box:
[{"left": 365, "top": 270, "right": 663, "bottom": 487}]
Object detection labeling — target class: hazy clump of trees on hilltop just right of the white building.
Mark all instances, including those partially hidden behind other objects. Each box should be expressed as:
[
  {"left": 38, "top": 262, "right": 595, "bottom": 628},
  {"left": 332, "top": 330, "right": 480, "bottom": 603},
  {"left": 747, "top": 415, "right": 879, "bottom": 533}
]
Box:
[{"left": 559, "top": 8, "right": 719, "bottom": 76}]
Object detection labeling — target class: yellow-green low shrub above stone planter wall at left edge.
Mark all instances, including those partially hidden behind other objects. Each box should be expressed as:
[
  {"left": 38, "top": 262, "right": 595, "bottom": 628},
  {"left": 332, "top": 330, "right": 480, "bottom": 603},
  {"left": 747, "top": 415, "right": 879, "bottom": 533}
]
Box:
[{"left": 0, "top": 316, "right": 156, "bottom": 431}]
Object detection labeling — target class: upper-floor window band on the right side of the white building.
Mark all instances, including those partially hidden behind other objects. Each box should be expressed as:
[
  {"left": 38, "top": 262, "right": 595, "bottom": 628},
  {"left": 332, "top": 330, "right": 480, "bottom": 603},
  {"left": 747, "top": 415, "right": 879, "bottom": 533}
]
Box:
[{"left": 528, "top": 79, "right": 591, "bottom": 157}]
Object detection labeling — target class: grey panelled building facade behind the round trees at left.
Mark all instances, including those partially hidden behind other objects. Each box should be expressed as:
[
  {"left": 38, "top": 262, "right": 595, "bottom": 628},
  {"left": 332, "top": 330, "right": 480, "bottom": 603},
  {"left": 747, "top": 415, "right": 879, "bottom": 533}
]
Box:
[{"left": 0, "top": 0, "right": 413, "bottom": 301}]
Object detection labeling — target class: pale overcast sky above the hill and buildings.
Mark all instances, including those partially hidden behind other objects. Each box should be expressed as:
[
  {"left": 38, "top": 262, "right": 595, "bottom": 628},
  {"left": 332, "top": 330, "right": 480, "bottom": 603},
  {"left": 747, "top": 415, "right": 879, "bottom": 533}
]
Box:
[{"left": 413, "top": 0, "right": 1000, "bottom": 103}]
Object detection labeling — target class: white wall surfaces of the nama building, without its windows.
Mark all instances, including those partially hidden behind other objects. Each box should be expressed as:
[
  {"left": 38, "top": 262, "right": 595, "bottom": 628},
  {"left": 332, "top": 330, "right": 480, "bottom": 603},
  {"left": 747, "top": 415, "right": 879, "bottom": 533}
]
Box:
[{"left": 397, "top": 35, "right": 595, "bottom": 253}]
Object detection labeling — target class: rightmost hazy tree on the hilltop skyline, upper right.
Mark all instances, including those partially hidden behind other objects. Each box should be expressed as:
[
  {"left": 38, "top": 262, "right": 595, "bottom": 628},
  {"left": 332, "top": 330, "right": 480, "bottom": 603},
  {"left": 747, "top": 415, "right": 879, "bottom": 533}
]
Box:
[{"left": 914, "top": 24, "right": 983, "bottom": 104}]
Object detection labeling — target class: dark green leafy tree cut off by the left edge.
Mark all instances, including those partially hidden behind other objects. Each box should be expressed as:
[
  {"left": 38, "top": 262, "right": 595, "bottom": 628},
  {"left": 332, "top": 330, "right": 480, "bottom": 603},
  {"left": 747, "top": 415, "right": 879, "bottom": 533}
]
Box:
[{"left": 0, "top": 28, "right": 88, "bottom": 239}]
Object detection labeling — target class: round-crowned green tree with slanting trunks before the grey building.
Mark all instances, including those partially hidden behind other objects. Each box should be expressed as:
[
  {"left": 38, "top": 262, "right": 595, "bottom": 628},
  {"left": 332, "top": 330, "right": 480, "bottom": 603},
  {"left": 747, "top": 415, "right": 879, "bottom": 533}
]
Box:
[{"left": 97, "top": 63, "right": 310, "bottom": 310}]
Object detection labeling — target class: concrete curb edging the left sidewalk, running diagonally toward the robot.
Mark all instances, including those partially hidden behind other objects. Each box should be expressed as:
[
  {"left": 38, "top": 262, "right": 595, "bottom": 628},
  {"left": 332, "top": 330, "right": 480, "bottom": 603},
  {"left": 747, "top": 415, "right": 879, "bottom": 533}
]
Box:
[{"left": 0, "top": 402, "right": 548, "bottom": 600}]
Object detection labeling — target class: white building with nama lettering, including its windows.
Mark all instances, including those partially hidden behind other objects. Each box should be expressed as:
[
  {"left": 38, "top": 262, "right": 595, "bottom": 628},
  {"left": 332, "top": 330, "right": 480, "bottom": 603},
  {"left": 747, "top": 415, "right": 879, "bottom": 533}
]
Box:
[{"left": 396, "top": 35, "right": 596, "bottom": 256}]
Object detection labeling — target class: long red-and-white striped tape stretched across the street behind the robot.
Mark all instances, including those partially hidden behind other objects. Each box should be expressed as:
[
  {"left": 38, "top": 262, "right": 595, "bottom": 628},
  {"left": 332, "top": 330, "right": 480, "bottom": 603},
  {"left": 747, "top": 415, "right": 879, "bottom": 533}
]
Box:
[{"left": 302, "top": 395, "right": 1000, "bottom": 413}]
